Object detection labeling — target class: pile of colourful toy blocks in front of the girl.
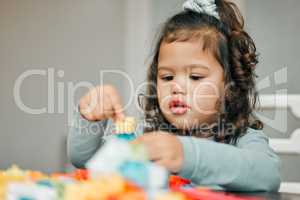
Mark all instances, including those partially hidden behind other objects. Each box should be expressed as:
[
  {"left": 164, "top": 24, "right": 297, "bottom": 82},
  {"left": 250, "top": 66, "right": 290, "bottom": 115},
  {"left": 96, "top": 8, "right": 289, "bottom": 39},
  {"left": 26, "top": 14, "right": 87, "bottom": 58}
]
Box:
[{"left": 0, "top": 118, "right": 253, "bottom": 200}]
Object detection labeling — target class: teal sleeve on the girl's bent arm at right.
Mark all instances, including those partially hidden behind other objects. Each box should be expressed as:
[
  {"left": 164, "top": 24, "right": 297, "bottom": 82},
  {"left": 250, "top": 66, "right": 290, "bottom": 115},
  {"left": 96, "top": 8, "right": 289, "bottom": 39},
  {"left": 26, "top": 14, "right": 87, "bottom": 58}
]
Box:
[{"left": 178, "top": 128, "right": 281, "bottom": 192}]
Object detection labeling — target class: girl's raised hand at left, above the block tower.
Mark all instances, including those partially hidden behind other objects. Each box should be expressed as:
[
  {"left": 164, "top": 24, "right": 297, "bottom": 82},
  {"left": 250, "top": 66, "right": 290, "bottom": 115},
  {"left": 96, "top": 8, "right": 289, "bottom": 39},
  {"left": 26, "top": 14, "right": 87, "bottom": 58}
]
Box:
[{"left": 79, "top": 85, "right": 125, "bottom": 121}]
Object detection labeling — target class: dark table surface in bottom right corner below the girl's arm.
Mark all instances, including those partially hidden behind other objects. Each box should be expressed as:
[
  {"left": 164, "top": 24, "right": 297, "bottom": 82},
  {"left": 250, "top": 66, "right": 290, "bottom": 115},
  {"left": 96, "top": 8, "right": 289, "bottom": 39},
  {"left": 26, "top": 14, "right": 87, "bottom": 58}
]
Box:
[{"left": 234, "top": 193, "right": 300, "bottom": 200}]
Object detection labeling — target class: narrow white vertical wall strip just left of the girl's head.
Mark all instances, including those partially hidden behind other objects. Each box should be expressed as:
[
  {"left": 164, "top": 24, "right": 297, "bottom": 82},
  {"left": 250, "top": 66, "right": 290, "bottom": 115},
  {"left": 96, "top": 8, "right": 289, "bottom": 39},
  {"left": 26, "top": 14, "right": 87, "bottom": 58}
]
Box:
[{"left": 124, "top": 0, "right": 152, "bottom": 116}]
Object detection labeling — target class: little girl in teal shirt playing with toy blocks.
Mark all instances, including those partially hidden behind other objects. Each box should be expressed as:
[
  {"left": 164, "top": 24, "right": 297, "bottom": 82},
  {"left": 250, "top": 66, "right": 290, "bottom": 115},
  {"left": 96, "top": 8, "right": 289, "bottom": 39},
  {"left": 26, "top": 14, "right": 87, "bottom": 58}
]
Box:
[{"left": 68, "top": 0, "right": 280, "bottom": 192}]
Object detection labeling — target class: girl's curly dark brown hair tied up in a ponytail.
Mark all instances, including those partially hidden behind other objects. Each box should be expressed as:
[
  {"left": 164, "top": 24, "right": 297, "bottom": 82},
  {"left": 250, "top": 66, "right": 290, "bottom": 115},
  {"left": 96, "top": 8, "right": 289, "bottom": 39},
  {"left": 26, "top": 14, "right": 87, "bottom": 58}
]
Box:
[{"left": 139, "top": 0, "right": 263, "bottom": 143}]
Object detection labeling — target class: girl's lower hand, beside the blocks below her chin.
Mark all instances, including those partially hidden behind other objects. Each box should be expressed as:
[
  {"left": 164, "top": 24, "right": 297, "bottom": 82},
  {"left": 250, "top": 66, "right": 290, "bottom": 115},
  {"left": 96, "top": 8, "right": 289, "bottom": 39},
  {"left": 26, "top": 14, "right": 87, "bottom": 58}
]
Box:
[{"left": 133, "top": 131, "right": 184, "bottom": 173}]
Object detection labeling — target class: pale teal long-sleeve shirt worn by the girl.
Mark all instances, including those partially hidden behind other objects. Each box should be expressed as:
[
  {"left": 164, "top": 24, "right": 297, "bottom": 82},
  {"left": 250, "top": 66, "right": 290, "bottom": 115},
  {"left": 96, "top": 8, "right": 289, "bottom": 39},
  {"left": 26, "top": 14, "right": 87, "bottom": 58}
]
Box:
[{"left": 68, "top": 109, "right": 280, "bottom": 192}]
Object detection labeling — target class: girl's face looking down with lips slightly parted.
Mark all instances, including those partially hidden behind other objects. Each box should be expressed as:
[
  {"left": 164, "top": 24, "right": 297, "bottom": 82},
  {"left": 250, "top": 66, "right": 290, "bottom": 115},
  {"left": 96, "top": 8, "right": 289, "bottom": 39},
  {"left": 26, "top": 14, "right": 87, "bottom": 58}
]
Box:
[{"left": 157, "top": 40, "right": 225, "bottom": 130}]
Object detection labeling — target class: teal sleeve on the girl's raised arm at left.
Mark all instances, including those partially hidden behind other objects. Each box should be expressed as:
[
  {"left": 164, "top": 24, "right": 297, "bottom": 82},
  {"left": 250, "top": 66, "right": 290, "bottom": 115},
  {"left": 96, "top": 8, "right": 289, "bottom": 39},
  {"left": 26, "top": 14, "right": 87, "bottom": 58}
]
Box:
[{"left": 67, "top": 107, "right": 108, "bottom": 168}]
